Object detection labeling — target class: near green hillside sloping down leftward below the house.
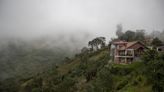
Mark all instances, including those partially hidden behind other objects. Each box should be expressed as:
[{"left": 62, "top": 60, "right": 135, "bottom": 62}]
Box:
[{"left": 0, "top": 47, "right": 164, "bottom": 92}]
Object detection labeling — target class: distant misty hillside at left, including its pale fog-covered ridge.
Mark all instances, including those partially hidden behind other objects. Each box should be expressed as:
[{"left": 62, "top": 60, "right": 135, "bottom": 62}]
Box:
[{"left": 0, "top": 39, "right": 82, "bottom": 80}]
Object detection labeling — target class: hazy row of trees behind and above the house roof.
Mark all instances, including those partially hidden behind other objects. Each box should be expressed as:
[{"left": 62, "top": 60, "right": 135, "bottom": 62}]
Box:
[{"left": 112, "top": 24, "right": 164, "bottom": 47}]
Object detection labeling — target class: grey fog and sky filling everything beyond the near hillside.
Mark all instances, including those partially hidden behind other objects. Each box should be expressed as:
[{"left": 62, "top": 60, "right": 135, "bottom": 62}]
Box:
[{"left": 0, "top": 0, "right": 164, "bottom": 80}]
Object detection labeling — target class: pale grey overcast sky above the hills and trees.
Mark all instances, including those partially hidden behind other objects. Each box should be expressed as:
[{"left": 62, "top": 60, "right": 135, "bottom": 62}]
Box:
[{"left": 0, "top": 0, "right": 164, "bottom": 38}]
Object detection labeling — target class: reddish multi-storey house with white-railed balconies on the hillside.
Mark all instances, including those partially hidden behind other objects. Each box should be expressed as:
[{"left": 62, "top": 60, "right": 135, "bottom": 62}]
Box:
[{"left": 110, "top": 41, "right": 147, "bottom": 64}]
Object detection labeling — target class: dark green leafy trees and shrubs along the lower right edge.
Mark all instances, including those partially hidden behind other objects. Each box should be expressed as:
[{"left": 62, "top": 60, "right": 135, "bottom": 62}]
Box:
[{"left": 143, "top": 50, "right": 164, "bottom": 92}]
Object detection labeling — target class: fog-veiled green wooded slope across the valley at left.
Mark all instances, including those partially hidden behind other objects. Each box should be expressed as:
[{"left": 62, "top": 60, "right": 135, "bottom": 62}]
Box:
[{"left": 0, "top": 42, "right": 70, "bottom": 80}]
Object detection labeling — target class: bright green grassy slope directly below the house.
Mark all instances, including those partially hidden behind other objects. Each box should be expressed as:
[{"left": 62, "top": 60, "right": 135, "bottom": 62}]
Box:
[{"left": 113, "top": 62, "right": 151, "bottom": 92}]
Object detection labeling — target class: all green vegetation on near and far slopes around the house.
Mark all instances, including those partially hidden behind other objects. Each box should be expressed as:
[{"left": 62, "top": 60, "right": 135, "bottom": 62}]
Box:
[{"left": 0, "top": 25, "right": 164, "bottom": 92}]
